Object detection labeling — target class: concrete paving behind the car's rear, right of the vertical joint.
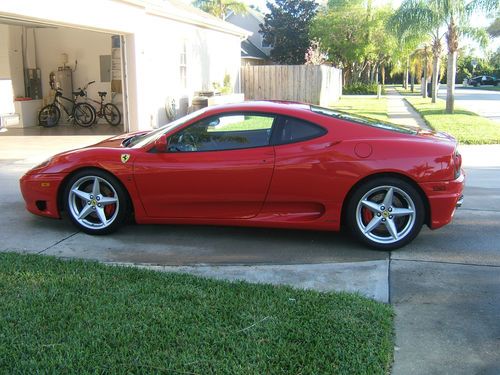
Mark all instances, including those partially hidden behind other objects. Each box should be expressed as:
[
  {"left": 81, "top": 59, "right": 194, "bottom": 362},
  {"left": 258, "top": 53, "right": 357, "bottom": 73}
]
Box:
[{"left": 389, "top": 146, "right": 500, "bottom": 375}]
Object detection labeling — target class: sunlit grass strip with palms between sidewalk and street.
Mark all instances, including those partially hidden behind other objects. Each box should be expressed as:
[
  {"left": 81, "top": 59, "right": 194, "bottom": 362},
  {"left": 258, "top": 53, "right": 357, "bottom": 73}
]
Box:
[{"left": 406, "top": 97, "right": 500, "bottom": 144}]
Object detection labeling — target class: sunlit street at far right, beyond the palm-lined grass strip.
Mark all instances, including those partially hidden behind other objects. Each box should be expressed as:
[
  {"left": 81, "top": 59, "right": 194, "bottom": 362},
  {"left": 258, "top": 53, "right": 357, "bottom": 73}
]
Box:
[{"left": 438, "top": 85, "right": 500, "bottom": 122}]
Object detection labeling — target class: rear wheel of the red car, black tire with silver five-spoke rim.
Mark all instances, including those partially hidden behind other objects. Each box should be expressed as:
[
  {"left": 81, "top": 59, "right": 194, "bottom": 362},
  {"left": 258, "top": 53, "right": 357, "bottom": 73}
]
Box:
[{"left": 346, "top": 177, "right": 425, "bottom": 251}]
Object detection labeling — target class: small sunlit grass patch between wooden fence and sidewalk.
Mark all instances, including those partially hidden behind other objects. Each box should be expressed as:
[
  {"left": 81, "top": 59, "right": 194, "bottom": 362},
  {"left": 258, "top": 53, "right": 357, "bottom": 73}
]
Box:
[{"left": 330, "top": 95, "right": 389, "bottom": 121}]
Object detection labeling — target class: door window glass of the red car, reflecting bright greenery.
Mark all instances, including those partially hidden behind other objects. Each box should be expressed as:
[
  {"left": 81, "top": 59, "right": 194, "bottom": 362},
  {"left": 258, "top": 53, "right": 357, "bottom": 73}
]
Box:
[{"left": 168, "top": 113, "right": 275, "bottom": 152}]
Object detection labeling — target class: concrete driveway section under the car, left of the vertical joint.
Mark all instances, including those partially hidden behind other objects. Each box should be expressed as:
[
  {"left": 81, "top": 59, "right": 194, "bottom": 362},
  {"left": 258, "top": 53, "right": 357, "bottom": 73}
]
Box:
[{"left": 0, "top": 134, "right": 389, "bottom": 302}]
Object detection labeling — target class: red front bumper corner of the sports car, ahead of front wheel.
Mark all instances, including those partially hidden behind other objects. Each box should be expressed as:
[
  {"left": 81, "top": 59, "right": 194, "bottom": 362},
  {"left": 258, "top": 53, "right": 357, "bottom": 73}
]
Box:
[{"left": 19, "top": 172, "right": 66, "bottom": 219}]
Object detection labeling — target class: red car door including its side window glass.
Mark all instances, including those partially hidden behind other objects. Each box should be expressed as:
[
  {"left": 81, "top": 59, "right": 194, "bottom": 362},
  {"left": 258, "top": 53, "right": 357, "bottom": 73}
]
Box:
[{"left": 134, "top": 113, "right": 275, "bottom": 219}]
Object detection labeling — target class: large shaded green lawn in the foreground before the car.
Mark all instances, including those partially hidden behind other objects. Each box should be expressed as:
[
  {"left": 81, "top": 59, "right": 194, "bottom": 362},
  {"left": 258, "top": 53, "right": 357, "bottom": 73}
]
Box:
[{"left": 0, "top": 253, "right": 394, "bottom": 375}]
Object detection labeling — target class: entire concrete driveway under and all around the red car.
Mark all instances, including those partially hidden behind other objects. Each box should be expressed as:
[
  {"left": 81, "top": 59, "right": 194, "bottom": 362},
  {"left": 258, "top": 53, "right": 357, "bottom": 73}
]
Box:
[{"left": 0, "top": 134, "right": 500, "bottom": 375}]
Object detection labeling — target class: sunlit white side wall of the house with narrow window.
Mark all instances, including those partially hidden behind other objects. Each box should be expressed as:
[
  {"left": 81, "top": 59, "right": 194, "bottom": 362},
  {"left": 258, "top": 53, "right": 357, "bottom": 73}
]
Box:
[{"left": 141, "top": 16, "right": 240, "bottom": 127}]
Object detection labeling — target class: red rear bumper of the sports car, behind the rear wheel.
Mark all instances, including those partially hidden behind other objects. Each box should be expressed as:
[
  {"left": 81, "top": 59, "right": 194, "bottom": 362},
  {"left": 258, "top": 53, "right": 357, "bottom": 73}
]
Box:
[{"left": 420, "top": 172, "right": 465, "bottom": 229}]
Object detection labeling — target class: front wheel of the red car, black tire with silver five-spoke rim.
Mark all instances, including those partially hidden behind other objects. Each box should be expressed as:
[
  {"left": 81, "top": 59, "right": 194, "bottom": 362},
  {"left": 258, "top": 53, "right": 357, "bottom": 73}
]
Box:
[{"left": 63, "top": 169, "right": 130, "bottom": 235}]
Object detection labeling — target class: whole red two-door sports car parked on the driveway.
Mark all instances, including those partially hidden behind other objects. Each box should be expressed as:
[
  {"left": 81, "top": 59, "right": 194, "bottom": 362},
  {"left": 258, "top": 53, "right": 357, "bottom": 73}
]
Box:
[{"left": 21, "top": 102, "right": 464, "bottom": 250}]
